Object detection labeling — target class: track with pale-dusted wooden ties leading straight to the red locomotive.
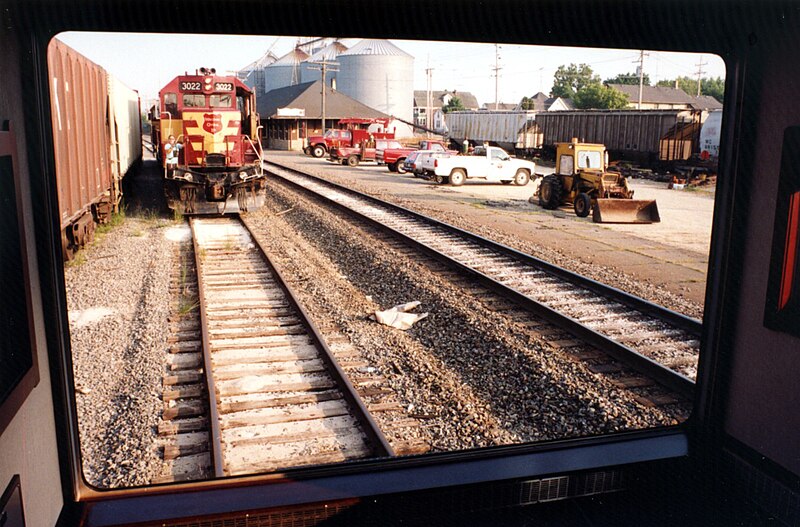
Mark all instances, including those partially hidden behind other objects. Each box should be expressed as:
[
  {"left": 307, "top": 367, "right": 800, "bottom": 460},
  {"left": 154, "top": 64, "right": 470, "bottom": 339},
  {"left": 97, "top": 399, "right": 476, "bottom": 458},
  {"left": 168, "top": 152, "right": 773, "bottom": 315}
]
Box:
[{"left": 177, "top": 218, "right": 394, "bottom": 477}]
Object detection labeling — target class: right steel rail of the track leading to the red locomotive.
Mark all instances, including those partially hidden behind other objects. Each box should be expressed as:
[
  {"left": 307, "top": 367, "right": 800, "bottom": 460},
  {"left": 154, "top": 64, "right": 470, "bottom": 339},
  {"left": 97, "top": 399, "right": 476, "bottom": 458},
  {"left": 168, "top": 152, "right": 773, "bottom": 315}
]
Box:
[{"left": 239, "top": 216, "right": 397, "bottom": 457}]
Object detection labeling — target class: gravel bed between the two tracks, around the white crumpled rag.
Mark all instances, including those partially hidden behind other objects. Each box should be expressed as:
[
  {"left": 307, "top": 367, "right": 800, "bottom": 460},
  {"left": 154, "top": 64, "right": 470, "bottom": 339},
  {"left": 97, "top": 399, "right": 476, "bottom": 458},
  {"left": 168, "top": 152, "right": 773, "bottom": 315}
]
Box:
[{"left": 249, "top": 185, "right": 684, "bottom": 451}]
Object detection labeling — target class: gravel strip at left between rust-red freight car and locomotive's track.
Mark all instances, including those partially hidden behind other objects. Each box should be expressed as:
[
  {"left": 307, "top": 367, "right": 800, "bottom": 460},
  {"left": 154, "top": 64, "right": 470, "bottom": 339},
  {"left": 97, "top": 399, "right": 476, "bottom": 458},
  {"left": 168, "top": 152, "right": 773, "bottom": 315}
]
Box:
[{"left": 65, "top": 217, "right": 173, "bottom": 488}]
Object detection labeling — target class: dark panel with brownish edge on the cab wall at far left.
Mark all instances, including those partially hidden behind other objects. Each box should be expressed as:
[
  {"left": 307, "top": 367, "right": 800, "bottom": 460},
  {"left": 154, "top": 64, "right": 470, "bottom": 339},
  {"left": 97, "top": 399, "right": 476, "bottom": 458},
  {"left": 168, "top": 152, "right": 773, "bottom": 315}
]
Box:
[{"left": 0, "top": 121, "right": 39, "bottom": 433}]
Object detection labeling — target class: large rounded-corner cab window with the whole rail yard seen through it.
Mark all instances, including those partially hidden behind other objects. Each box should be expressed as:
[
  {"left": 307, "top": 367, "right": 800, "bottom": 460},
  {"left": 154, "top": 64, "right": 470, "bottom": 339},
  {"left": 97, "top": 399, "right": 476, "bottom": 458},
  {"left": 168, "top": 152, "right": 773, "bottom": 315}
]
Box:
[{"left": 48, "top": 32, "right": 724, "bottom": 491}]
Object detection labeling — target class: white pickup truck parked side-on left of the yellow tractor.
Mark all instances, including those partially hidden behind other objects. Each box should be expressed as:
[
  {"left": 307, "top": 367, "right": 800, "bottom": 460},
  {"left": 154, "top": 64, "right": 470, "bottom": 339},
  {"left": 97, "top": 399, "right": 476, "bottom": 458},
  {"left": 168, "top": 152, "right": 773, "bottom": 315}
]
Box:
[{"left": 424, "top": 146, "right": 536, "bottom": 186}]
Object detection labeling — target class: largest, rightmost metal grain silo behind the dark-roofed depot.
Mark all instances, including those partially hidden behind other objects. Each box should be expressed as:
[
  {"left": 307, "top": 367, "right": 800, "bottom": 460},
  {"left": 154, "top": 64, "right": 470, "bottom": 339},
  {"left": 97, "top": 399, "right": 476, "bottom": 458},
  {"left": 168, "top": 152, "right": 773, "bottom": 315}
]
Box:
[{"left": 336, "top": 40, "right": 414, "bottom": 121}]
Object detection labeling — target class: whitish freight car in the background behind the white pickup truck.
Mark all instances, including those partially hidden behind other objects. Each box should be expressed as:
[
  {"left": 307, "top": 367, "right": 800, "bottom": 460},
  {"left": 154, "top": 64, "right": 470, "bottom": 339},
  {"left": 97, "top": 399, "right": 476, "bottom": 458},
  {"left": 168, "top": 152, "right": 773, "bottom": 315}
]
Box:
[{"left": 445, "top": 110, "right": 543, "bottom": 152}]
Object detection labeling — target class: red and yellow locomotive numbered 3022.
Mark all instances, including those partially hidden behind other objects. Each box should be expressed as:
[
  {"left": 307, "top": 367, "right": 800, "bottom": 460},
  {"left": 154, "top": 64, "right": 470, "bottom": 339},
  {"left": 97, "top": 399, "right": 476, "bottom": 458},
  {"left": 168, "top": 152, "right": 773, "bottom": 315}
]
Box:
[{"left": 150, "top": 68, "right": 265, "bottom": 214}]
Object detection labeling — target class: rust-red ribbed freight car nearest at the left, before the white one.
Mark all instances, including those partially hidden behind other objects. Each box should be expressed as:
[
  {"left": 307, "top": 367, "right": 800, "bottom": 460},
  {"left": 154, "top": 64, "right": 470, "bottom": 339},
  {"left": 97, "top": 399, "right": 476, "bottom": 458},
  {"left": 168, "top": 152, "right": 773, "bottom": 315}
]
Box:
[{"left": 47, "top": 39, "right": 111, "bottom": 255}]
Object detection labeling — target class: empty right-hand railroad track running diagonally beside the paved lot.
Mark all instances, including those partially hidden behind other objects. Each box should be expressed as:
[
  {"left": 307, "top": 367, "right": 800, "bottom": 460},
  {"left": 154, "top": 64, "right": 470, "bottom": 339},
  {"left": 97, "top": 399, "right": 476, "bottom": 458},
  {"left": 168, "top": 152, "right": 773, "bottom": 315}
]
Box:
[{"left": 267, "top": 163, "right": 702, "bottom": 397}]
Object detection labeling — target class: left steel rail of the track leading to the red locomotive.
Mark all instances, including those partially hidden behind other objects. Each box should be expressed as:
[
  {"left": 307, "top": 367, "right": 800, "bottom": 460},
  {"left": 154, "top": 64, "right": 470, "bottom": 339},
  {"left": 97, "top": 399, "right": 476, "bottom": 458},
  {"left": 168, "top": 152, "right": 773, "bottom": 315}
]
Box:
[{"left": 189, "top": 218, "right": 225, "bottom": 478}]
